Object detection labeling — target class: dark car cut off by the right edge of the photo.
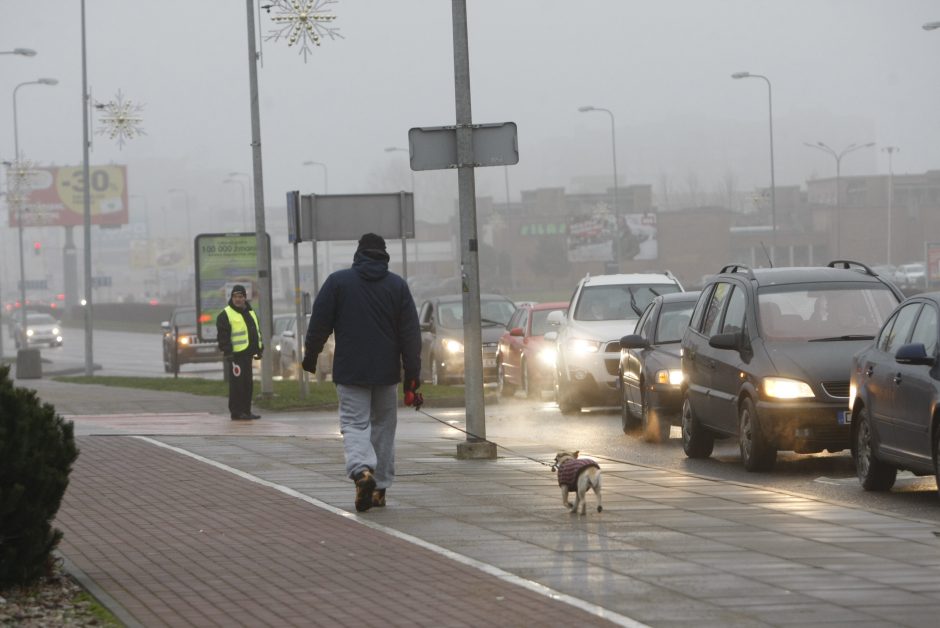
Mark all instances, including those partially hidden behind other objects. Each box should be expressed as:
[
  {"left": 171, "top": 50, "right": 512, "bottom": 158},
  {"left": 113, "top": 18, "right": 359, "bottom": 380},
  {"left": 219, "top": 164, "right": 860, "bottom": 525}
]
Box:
[{"left": 849, "top": 292, "right": 940, "bottom": 491}]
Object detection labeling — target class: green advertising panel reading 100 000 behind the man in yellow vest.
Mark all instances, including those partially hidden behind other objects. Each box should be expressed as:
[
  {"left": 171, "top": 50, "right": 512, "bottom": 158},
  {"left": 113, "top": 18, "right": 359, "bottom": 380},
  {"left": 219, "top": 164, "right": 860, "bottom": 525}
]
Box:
[{"left": 195, "top": 233, "right": 271, "bottom": 342}]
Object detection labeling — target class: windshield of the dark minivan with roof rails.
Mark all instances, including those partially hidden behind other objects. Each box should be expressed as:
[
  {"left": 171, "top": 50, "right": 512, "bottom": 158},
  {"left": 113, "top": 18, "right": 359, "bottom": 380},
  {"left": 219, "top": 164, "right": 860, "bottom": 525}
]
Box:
[{"left": 757, "top": 284, "right": 898, "bottom": 340}]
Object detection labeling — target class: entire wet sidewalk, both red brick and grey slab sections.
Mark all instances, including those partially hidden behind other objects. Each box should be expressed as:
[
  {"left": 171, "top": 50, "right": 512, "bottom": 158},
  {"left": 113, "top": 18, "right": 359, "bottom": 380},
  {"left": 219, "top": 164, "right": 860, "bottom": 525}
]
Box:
[{"left": 20, "top": 382, "right": 940, "bottom": 627}]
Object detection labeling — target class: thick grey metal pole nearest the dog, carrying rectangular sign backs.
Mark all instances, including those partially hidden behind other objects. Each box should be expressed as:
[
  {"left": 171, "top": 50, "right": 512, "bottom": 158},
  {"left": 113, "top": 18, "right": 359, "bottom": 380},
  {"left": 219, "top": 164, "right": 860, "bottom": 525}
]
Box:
[{"left": 451, "top": 0, "right": 488, "bottom": 458}]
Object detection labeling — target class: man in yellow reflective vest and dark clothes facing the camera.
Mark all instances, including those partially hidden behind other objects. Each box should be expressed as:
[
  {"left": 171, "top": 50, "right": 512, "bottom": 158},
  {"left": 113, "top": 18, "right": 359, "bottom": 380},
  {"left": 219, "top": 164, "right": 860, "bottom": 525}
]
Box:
[{"left": 215, "top": 284, "right": 263, "bottom": 421}]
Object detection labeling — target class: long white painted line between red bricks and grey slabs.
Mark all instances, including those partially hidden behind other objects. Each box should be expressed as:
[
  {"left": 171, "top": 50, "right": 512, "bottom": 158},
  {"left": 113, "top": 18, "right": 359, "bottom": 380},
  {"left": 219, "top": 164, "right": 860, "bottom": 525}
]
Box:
[{"left": 133, "top": 436, "right": 648, "bottom": 628}]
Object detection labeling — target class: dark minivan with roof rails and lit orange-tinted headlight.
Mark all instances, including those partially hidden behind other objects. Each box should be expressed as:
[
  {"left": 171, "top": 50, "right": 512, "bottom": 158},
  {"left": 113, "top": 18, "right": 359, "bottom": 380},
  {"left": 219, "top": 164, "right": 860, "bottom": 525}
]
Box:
[{"left": 682, "top": 260, "right": 903, "bottom": 471}]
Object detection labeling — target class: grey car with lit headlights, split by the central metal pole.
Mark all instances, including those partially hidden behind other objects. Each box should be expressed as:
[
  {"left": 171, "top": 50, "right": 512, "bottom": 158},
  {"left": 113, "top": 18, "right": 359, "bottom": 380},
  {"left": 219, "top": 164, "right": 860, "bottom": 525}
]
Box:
[{"left": 418, "top": 294, "right": 516, "bottom": 385}]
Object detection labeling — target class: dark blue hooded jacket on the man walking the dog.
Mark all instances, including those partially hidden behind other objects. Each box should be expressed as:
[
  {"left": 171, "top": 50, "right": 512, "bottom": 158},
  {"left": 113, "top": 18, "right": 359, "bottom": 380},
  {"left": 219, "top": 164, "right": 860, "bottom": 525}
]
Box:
[{"left": 304, "top": 252, "right": 421, "bottom": 386}]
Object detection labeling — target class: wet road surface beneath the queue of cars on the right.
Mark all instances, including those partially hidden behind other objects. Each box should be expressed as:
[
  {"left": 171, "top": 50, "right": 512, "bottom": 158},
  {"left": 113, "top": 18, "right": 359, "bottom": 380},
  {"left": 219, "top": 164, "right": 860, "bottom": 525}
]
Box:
[{"left": 484, "top": 397, "right": 940, "bottom": 523}]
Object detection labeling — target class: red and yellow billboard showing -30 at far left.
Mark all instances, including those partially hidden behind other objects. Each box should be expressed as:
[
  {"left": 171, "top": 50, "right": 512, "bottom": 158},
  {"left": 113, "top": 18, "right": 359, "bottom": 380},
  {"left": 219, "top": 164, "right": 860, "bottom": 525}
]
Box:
[{"left": 7, "top": 166, "right": 127, "bottom": 227}]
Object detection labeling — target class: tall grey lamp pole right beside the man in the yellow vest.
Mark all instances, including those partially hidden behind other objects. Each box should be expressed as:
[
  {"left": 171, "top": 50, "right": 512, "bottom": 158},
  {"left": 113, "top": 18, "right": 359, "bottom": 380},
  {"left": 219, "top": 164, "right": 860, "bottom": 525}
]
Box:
[{"left": 245, "top": 0, "right": 274, "bottom": 399}]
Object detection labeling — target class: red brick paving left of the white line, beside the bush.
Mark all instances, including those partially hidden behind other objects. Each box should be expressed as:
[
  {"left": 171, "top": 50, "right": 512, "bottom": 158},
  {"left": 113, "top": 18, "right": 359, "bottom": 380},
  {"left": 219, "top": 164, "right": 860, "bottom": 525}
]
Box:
[{"left": 56, "top": 436, "right": 628, "bottom": 626}]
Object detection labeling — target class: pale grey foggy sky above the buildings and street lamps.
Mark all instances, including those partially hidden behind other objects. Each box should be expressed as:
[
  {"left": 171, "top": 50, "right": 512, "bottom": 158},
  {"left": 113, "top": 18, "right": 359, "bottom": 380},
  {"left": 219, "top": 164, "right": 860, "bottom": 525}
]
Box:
[{"left": 0, "top": 0, "right": 940, "bottom": 228}]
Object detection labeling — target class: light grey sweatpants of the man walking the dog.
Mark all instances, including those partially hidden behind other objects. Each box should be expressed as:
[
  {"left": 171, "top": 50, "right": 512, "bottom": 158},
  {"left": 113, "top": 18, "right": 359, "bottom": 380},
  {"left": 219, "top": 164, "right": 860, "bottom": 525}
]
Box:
[{"left": 336, "top": 384, "right": 398, "bottom": 488}]
